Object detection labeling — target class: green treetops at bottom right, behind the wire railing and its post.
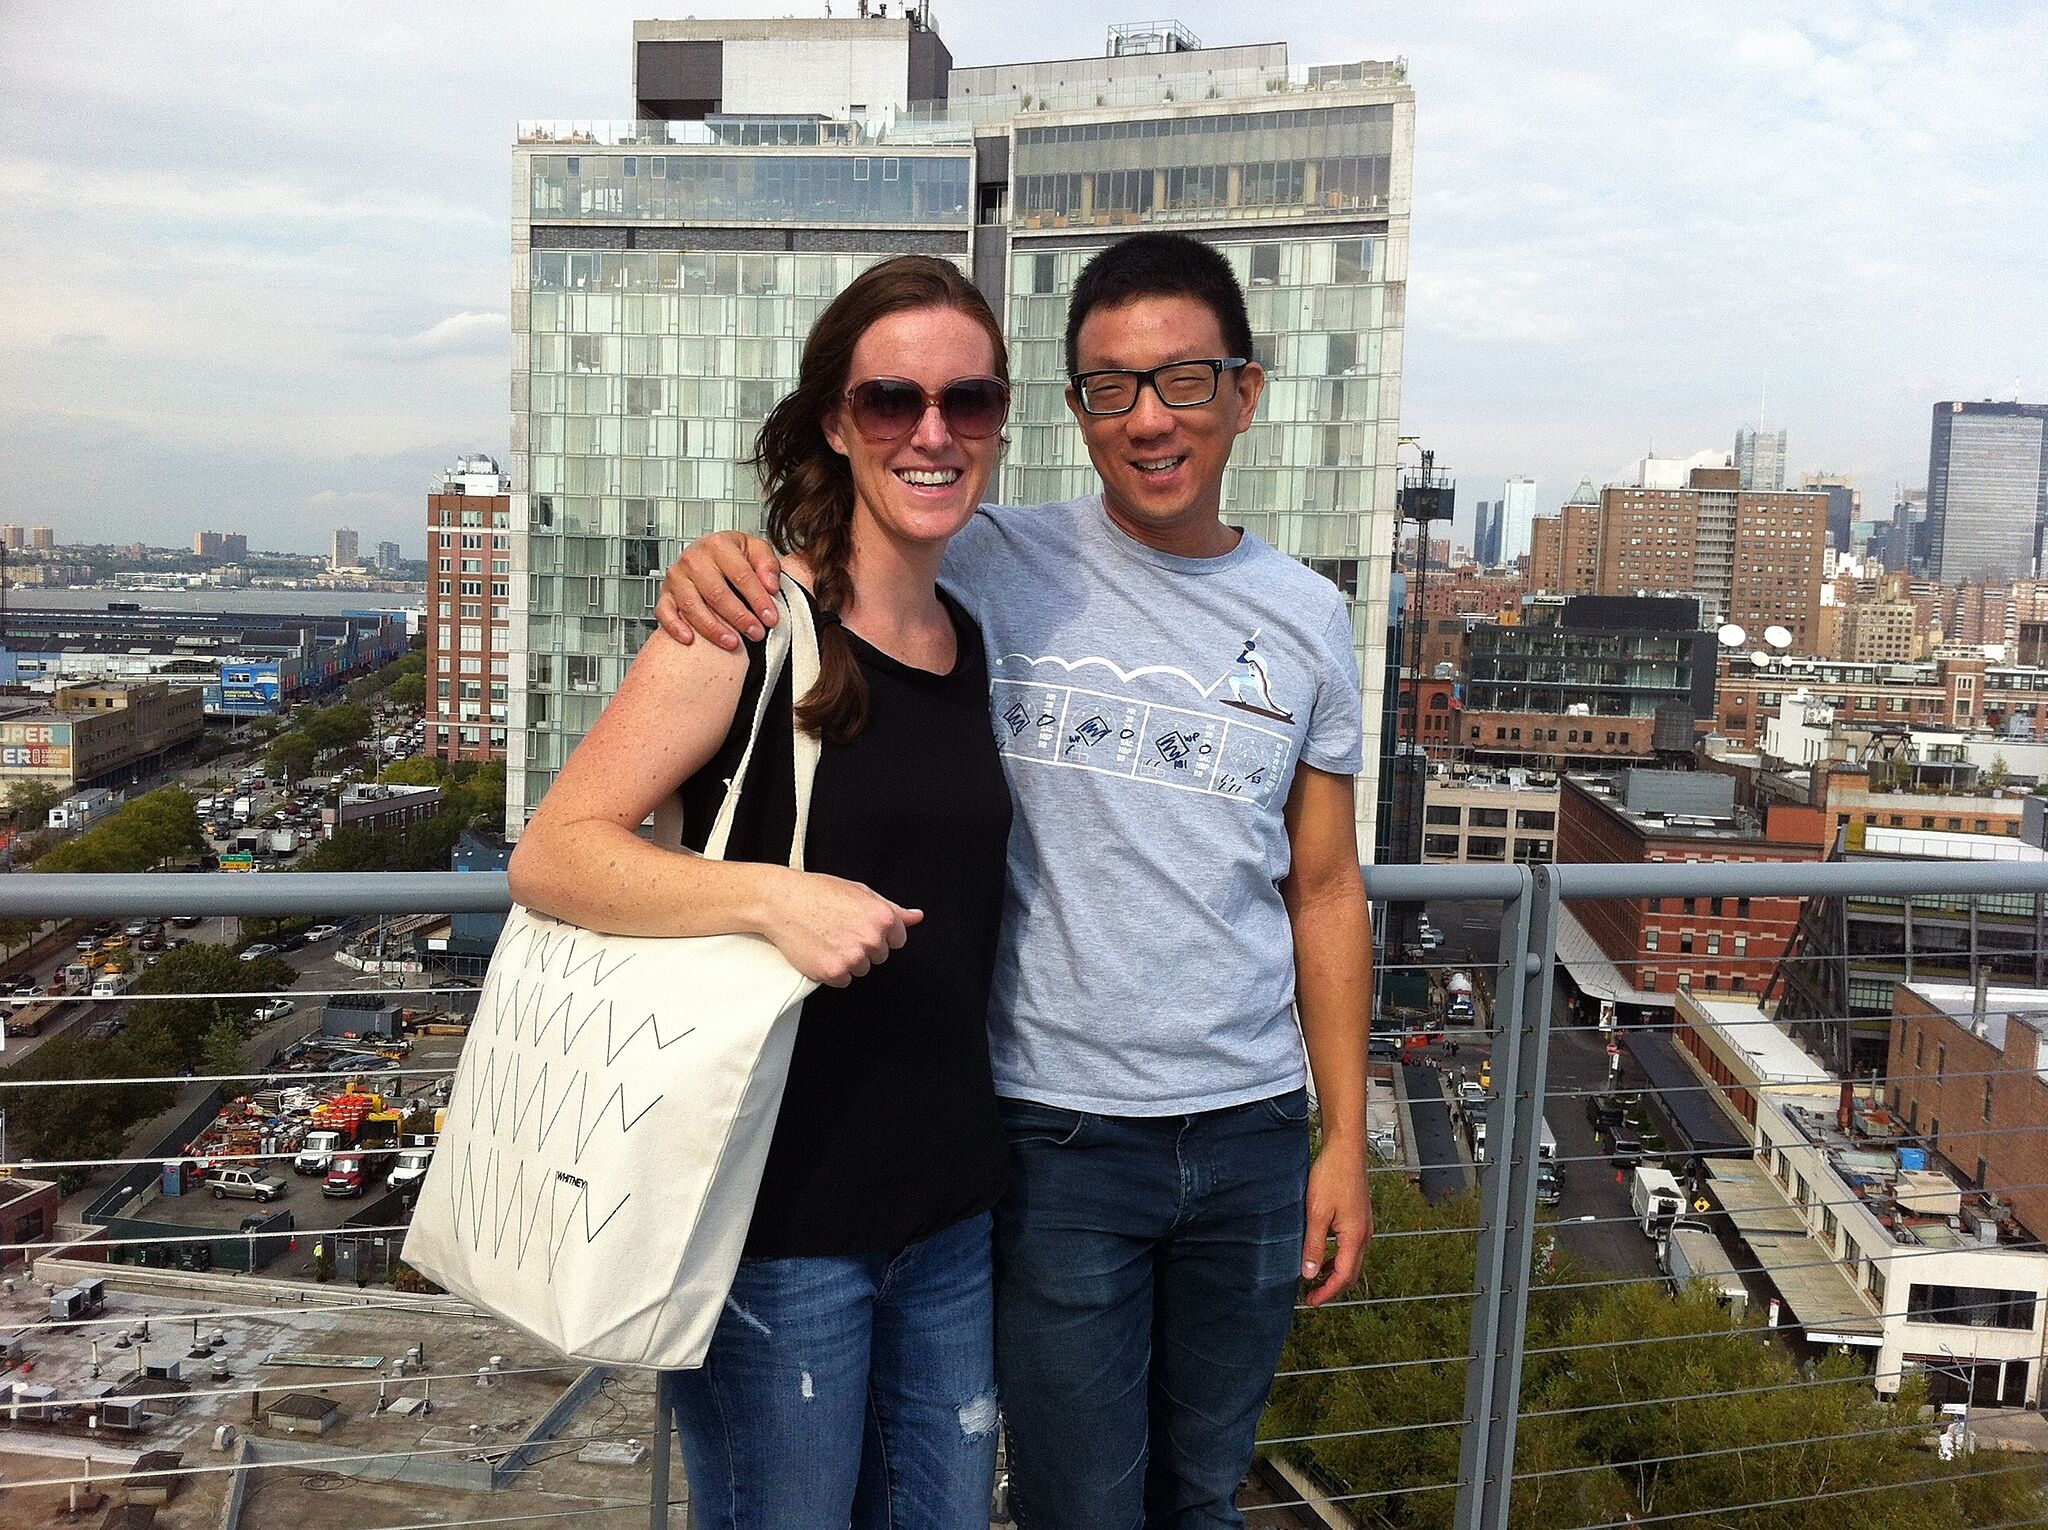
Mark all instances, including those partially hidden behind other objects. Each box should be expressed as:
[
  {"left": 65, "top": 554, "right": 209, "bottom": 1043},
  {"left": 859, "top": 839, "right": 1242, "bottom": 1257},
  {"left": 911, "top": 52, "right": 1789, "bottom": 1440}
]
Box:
[{"left": 1260, "top": 1174, "right": 2038, "bottom": 1530}]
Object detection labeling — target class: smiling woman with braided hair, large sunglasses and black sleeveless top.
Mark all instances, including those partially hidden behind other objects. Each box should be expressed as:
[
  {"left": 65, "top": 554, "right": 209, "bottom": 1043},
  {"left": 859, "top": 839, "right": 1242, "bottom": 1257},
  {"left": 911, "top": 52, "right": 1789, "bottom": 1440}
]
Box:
[{"left": 512, "top": 256, "right": 1010, "bottom": 1530}]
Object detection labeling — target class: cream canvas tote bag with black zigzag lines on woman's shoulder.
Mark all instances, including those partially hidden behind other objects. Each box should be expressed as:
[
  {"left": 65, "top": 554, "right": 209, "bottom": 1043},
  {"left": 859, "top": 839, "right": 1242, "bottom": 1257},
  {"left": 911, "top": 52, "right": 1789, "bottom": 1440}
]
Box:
[{"left": 403, "top": 580, "right": 817, "bottom": 1370}]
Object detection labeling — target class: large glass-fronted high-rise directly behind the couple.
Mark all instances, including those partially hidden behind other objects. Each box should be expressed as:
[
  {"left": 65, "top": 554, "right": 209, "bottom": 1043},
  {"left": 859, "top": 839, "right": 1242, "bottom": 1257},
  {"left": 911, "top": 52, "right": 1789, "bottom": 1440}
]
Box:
[{"left": 508, "top": 16, "right": 1415, "bottom": 844}]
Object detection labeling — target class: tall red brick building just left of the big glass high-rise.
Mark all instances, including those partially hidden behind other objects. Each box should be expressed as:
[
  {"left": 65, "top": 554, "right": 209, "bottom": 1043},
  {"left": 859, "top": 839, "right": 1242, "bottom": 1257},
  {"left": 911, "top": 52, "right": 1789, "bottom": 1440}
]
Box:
[{"left": 426, "top": 457, "right": 512, "bottom": 760}]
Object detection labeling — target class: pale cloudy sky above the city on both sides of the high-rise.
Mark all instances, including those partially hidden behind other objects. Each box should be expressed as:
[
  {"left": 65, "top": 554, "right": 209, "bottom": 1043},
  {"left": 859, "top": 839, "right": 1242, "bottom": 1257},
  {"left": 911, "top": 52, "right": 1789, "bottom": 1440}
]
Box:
[{"left": 0, "top": 0, "right": 2048, "bottom": 555}]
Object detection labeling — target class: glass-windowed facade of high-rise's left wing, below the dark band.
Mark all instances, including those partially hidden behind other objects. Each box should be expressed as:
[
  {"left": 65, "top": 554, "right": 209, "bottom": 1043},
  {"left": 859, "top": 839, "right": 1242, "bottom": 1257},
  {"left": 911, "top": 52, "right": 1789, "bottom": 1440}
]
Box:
[{"left": 508, "top": 250, "right": 933, "bottom": 805}]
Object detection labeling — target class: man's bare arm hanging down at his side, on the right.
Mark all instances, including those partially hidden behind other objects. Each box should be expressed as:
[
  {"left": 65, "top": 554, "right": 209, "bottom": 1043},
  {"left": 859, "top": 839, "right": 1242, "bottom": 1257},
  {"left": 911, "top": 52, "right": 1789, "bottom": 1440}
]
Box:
[{"left": 1280, "top": 764, "right": 1372, "bottom": 1307}]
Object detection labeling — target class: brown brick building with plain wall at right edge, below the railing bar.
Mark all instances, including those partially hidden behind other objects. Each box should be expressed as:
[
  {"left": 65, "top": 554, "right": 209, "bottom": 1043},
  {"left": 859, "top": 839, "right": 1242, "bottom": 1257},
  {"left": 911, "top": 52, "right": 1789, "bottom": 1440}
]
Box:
[{"left": 1884, "top": 983, "right": 2048, "bottom": 1253}]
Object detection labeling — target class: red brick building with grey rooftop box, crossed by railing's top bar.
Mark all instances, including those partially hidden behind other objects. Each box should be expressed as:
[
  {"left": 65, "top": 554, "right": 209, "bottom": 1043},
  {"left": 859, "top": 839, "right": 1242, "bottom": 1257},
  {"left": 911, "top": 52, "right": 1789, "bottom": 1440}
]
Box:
[{"left": 1556, "top": 770, "right": 1821, "bottom": 1004}]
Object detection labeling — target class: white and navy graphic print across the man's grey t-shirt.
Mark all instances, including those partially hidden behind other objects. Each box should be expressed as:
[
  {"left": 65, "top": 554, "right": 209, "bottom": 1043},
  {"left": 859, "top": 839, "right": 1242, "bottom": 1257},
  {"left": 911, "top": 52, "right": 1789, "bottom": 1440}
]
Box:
[{"left": 989, "top": 631, "right": 1294, "bottom": 807}]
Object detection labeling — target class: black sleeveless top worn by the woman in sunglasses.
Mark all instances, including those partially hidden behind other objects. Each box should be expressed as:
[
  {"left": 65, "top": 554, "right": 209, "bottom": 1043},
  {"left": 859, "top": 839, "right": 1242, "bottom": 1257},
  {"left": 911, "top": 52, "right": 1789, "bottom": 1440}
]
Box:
[{"left": 682, "top": 594, "right": 1010, "bottom": 1258}]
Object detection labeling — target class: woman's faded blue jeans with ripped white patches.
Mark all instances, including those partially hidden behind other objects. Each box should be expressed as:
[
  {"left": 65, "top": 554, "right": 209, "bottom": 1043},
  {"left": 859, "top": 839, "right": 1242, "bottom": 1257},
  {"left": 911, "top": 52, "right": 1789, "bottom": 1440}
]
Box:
[{"left": 664, "top": 1213, "right": 997, "bottom": 1530}]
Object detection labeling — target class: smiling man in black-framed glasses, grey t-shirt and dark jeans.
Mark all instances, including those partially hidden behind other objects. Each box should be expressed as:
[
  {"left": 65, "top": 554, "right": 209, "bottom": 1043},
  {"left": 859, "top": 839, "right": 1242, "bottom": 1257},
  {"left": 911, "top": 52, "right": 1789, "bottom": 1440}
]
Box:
[{"left": 659, "top": 233, "right": 1372, "bottom": 1530}]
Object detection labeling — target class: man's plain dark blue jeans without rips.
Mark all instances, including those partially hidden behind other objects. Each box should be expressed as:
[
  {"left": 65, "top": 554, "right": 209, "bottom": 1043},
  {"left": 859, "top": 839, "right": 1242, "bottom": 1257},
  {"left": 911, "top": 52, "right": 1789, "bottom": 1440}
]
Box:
[{"left": 995, "top": 1090, "right": 1309, "bottom": 1530}]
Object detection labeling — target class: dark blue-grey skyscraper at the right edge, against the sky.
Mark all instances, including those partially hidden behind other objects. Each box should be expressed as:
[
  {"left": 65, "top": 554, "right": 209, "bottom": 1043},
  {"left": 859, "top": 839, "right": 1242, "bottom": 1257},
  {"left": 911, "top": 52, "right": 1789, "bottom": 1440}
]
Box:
[{"left": 1927, "top": 399, "right": 2048, "bottom": 584}]
